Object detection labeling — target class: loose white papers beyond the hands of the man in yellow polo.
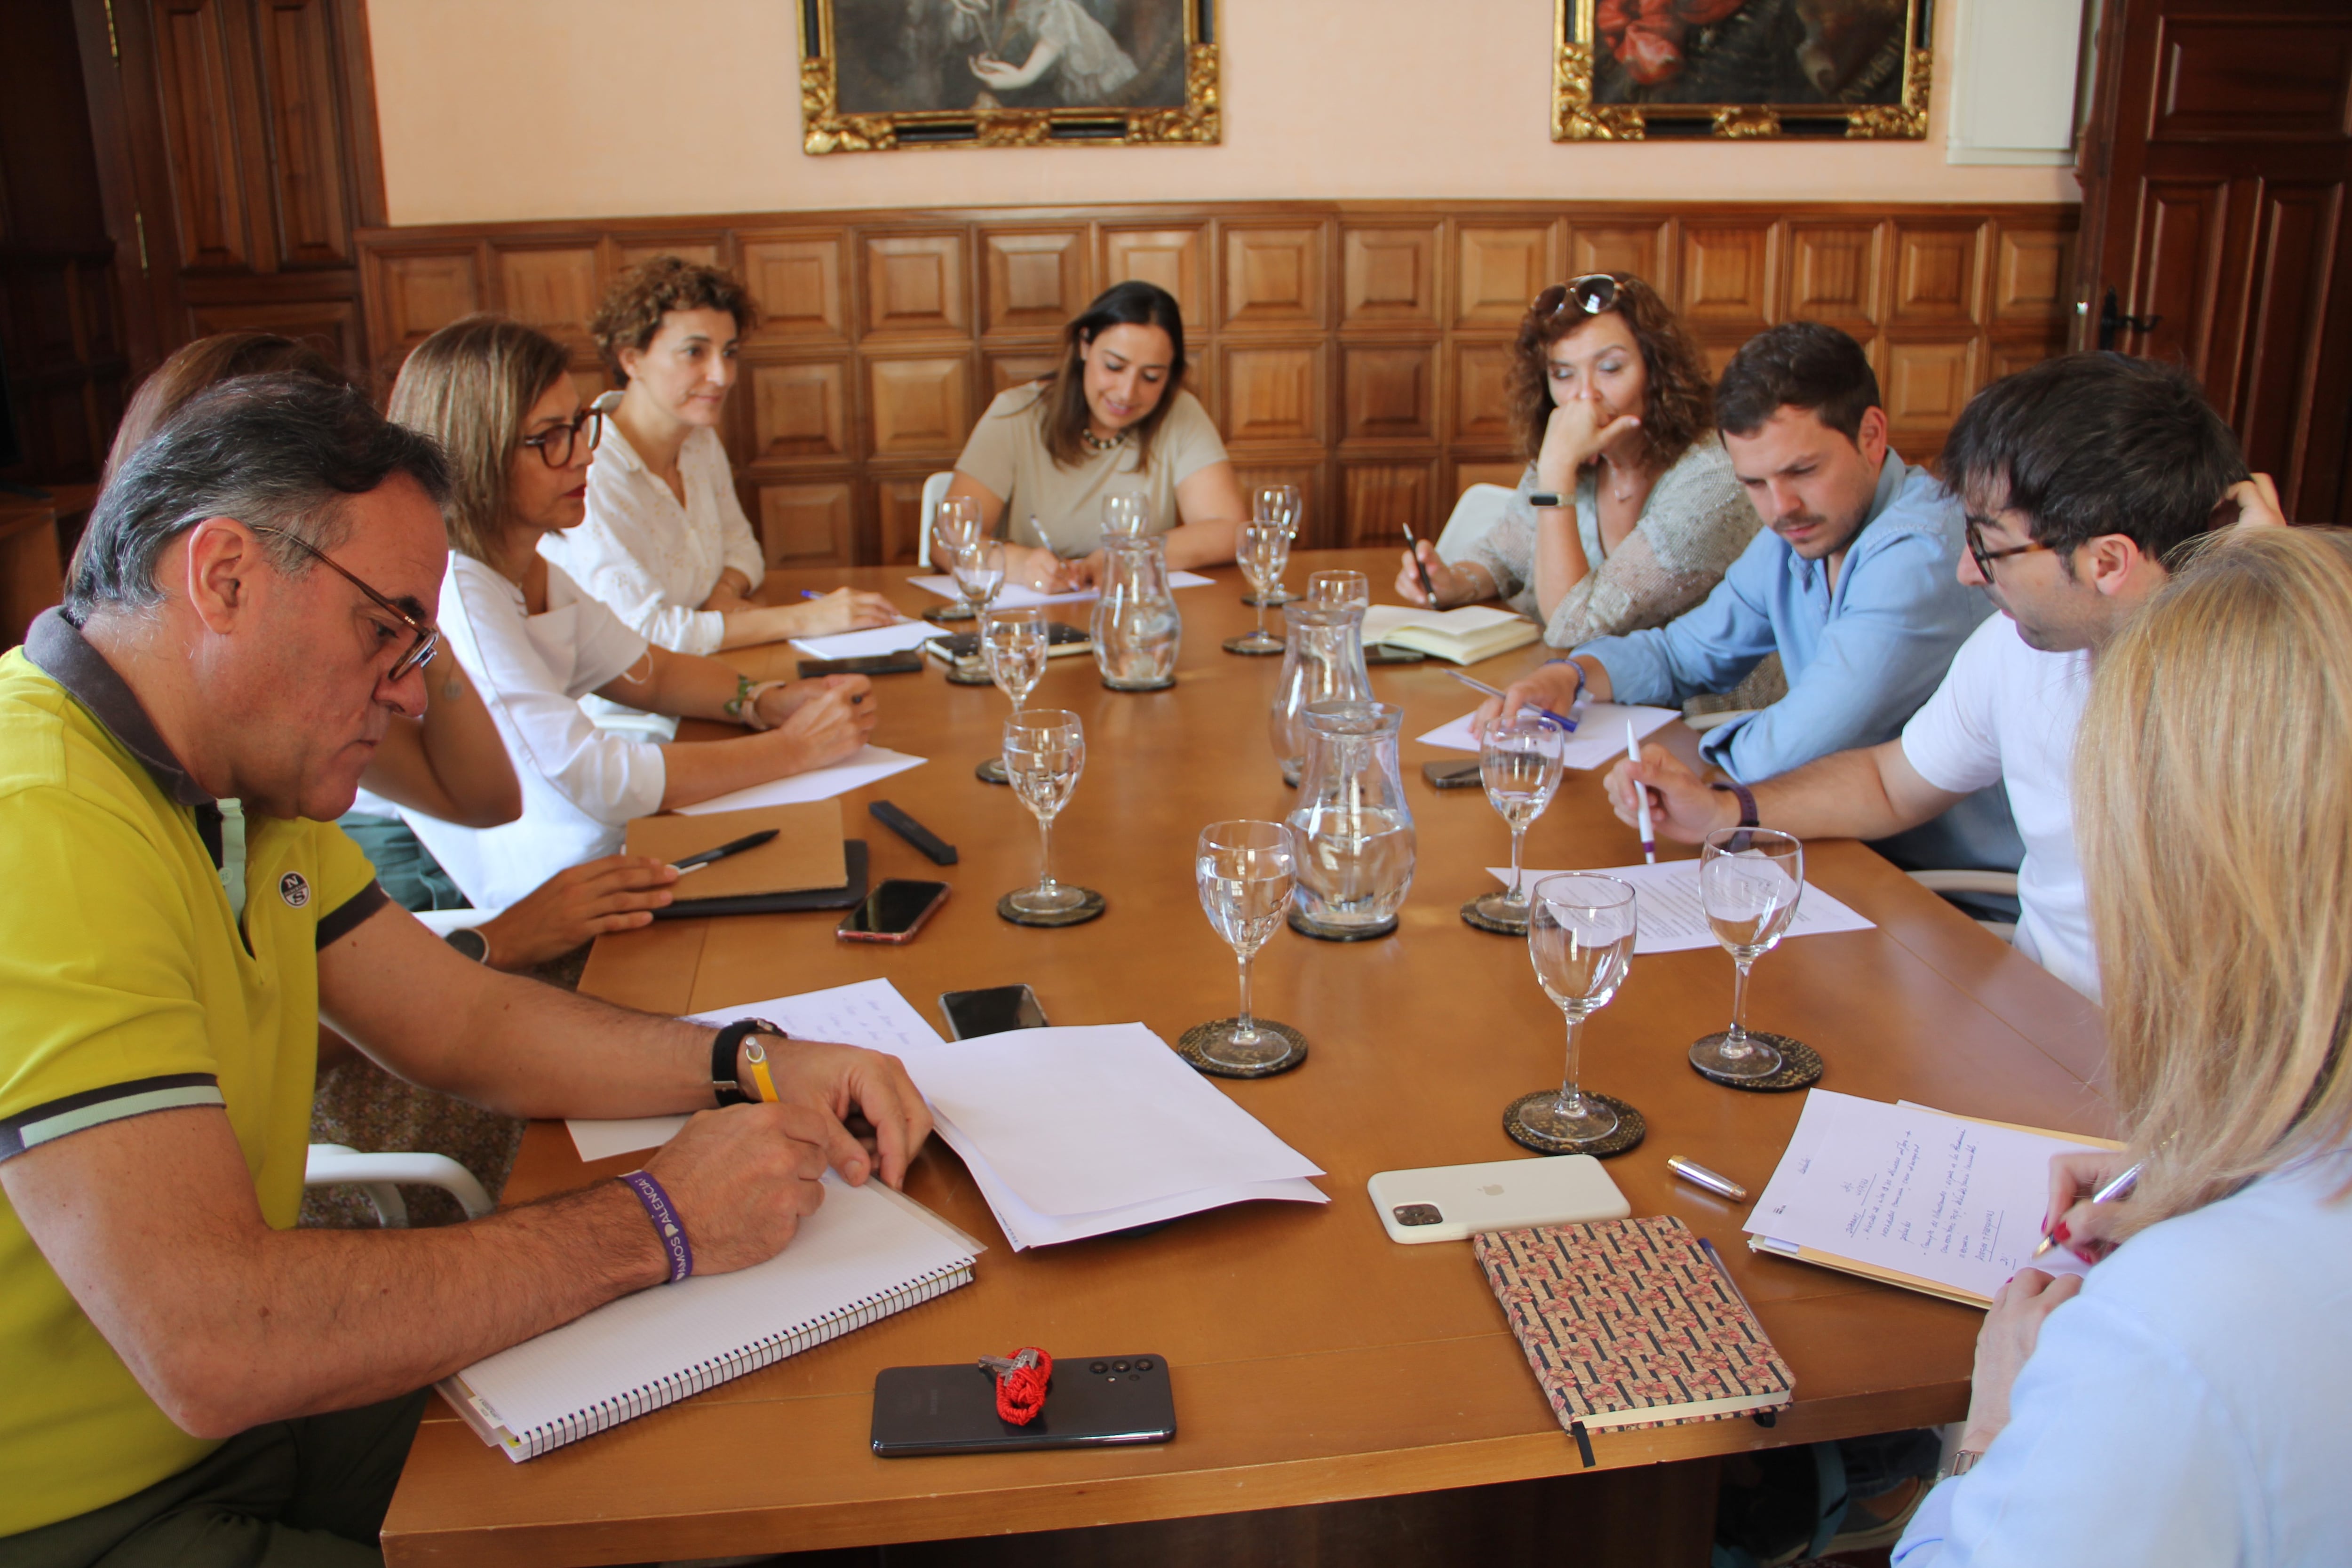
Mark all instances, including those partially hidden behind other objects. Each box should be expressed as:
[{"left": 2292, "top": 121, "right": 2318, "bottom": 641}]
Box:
[{"left": 572, "top": 980, "right": 1331, "bottom": 1250}]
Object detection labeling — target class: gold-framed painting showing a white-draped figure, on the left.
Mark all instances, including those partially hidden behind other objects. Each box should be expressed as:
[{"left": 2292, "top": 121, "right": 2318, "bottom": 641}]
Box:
[{"left": 800, "top": 0, "right": 1223, "bottom": 155}]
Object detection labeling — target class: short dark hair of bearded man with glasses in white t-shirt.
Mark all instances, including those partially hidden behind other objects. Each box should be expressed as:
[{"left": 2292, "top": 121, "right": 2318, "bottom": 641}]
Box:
[{"left": 1943, "top": 350, "right": 2246, "bottom": 571}]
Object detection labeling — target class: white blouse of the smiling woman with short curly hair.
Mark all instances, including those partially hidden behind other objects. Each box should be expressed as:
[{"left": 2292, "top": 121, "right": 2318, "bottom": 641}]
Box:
[{"left": 539, "top": 421, "right": 767, "bottom": 653}]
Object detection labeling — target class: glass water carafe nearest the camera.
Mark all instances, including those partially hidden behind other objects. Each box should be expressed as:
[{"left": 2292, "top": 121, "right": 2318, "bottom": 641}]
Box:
[{"left": 1284, "top": 700, "right": 1414, "bottom": 940}]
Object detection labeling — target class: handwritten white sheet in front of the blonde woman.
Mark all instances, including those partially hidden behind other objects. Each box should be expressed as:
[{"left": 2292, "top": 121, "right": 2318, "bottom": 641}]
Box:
[{"left": 1745, "top": 1089, "right": 2096, "bottom": 1300}]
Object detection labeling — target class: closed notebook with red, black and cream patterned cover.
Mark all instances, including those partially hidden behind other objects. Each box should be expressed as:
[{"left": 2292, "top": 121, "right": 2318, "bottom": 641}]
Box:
[{"left": 1472, "top": 1215, "right": 1797, "bottom": 1432}]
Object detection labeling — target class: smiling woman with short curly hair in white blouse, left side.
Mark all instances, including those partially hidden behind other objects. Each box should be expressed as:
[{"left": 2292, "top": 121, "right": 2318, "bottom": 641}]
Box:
[{"left": 539, "top": 256, "right": 898, "bottom": 653}]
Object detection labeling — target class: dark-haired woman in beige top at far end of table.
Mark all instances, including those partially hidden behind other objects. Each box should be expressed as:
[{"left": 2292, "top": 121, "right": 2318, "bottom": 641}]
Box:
[{"left": 948, "top": 282, "right": 1249, "bottom": 592}]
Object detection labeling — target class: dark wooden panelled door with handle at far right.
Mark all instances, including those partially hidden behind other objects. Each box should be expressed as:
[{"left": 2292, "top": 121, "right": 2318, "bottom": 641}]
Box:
[{"left": 2077, "top": 0, "right": 2352, "bottom": 522}]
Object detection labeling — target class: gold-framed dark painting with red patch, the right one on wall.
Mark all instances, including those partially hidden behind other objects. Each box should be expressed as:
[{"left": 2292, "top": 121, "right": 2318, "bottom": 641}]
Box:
[{"left": 1552, "top": 0, "right": 1933, "bottom": 141}]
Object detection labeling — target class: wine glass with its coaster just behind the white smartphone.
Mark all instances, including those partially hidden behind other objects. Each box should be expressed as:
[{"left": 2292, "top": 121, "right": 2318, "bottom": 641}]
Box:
[{"left": 1503, "top": 872, "right": 1635, "bottom": 1154}]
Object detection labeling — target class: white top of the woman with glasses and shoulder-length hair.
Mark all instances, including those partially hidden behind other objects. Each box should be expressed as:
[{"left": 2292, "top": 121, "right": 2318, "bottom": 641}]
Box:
[{"left": 400, "top": 550, "right": 668, "bottom": 910}]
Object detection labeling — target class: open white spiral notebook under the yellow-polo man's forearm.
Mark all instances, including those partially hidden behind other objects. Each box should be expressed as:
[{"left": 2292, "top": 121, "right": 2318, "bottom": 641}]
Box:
[{"left": 435, "top": 1173, "right": 985, "bottom": 1465}]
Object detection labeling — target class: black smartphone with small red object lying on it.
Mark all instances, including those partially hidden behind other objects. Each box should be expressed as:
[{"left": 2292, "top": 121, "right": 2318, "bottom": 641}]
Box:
[{"left": 873, "top": 1356, "right": 1176, "bottom": 1460}]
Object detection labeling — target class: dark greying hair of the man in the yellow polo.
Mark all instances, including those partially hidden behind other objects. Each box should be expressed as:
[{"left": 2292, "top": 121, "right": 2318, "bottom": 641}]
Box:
[{"left": 66, "top": 372, "right": 449, "bottom": 625}]
